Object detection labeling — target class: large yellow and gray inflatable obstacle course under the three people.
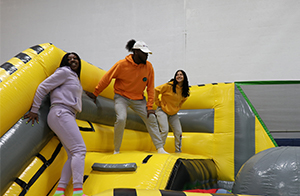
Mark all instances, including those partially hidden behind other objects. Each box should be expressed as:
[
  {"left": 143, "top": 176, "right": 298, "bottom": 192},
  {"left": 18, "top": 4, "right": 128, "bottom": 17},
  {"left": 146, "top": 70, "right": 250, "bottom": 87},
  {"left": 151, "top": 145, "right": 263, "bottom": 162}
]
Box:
[{"left": 0, "top": 43, "right": 277, "bottom": 196}]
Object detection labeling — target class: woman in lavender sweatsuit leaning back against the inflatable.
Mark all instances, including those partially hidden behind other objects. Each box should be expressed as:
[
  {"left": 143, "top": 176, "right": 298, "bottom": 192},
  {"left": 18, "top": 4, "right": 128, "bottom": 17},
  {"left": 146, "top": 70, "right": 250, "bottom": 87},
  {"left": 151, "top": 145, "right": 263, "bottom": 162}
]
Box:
[{"left": 24, "top": 53, "right": 86, "bottom": 196}]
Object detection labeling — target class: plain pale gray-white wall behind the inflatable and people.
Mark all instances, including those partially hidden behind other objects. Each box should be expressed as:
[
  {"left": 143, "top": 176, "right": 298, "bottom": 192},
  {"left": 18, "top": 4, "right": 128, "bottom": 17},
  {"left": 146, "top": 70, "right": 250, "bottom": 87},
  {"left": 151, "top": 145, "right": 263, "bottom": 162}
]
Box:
[{"left": 0, "top": 0, "right": 300, "bottom": 85}]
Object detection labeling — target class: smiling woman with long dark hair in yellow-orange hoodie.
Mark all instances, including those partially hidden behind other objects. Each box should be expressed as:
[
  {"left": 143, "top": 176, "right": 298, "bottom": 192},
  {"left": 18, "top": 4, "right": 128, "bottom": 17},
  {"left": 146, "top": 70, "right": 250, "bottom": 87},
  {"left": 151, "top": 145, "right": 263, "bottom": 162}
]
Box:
[{"left": 155, "top": 70, "right": 190, "bottom": 153}]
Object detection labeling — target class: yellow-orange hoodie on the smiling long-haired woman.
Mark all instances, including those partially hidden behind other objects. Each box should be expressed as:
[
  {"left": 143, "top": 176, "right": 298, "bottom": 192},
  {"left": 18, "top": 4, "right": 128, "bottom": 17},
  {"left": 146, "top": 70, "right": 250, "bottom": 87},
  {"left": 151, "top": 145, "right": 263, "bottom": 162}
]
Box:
[{"left": 154, "top": 82, "right": 187, "bottom": 115}]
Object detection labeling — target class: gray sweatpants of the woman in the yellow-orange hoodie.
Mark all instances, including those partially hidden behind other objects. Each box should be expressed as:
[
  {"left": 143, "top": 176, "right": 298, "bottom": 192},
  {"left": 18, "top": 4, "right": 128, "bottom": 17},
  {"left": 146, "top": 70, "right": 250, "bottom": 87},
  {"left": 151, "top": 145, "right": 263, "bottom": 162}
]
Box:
[{"left": 155, "top": 107, "right": 182, "bottom": 152}]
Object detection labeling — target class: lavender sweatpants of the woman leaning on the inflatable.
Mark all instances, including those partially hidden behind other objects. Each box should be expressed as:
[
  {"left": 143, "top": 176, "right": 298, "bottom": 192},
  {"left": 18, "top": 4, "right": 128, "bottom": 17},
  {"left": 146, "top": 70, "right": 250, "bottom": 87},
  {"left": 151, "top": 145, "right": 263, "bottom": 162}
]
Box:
[{"left": 47, "top": 105, "right": 86, "bottom": 188}]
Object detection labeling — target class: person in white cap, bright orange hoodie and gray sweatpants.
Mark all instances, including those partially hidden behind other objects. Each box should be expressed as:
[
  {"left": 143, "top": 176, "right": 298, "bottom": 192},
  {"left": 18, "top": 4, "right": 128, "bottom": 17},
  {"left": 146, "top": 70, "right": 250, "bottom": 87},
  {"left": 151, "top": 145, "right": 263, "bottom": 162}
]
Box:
[{"left": 86, "top": 39, "right": 167, "bottom": 154}]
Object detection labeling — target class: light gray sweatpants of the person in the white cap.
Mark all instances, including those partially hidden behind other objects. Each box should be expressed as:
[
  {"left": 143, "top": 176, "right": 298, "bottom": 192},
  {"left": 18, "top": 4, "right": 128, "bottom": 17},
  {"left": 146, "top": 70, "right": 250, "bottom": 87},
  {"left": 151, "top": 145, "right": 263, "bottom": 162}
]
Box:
[{"left": 114, "top": 94, "right": 163, "bottom": 151}]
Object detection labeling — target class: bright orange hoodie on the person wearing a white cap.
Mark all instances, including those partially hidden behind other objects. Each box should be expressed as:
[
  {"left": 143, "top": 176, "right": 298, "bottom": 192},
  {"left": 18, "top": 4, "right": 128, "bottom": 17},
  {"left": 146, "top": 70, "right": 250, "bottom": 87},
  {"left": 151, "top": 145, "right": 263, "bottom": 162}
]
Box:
[{"left": 94, "top": 54, "right": 154, "bottom": 110}]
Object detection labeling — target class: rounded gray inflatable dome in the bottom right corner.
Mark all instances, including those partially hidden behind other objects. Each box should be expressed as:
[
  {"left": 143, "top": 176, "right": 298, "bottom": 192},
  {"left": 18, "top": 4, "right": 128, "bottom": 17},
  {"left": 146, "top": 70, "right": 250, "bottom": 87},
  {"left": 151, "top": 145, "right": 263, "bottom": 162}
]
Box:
[{"left": 233, "top": 146, "right": 300, "bottom": 196}]
